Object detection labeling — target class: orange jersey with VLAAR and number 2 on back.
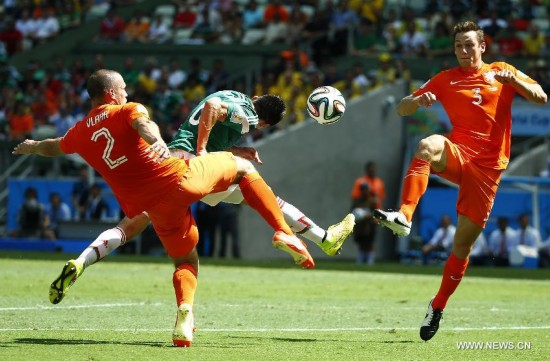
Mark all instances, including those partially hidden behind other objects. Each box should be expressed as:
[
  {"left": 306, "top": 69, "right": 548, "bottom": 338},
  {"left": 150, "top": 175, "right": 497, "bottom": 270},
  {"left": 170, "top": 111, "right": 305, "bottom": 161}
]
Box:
[{"left": 60, "top": 103, "right": 187, "bottom": 217}]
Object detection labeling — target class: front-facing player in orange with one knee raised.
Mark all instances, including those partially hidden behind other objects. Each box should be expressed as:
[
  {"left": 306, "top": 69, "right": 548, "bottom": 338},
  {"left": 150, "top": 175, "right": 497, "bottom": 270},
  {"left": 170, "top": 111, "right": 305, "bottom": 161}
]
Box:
[{"left": 374, "top": 21, "right": 547, "bottom": 341}]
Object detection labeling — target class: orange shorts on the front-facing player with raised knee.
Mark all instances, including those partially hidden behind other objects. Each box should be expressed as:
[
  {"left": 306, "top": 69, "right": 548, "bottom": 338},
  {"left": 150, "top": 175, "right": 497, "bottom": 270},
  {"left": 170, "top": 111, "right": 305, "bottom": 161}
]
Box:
[{"left": 432, "top": 139, "right": 503, "bottom": 228}]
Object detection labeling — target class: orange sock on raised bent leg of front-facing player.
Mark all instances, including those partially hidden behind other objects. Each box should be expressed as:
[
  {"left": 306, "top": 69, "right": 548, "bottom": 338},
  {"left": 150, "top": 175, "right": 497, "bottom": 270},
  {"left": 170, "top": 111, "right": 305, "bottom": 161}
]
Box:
[{"left": 399, "top": 157, "right": 430, "bottom": 222}]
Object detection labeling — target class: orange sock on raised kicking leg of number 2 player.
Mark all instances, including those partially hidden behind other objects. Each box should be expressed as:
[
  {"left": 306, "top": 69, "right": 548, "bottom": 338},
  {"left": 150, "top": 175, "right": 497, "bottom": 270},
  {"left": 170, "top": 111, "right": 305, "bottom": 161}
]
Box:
[{"left": 239, "top": 172, "right": 293, "bottom": 235}]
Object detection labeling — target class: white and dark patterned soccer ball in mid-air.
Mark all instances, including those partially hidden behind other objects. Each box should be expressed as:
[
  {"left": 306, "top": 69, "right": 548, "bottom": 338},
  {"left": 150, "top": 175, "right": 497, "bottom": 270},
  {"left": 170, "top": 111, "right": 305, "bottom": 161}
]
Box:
[{"left": 307, "top": 85, "right": 346, "bottom": 125}]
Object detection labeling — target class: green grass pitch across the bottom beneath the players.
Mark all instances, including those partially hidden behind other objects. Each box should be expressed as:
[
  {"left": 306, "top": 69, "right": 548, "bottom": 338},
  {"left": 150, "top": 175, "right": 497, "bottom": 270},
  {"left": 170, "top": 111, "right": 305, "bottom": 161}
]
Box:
[{"left": 0, "top": 252, "right": 550, "bottom": 361}]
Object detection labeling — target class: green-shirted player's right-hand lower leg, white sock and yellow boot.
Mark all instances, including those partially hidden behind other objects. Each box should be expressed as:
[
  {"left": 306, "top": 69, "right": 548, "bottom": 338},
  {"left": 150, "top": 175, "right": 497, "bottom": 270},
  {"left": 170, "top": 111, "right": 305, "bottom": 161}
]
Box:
[{"left": 277, "top": 197, "right": 355, "bottom": 256}]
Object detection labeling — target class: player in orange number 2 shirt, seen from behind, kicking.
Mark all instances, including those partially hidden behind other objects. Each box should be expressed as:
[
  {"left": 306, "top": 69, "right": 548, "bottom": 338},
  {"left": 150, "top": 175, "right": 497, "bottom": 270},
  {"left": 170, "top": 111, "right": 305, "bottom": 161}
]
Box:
[{"left": 13, "top": 69, "right": 314, "bottom": 346}]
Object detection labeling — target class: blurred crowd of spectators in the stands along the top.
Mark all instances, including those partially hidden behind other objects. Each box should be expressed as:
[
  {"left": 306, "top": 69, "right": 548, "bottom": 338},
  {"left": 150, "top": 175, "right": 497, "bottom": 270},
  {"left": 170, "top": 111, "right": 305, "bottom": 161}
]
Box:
[{"left": 0, "top": 0, "right": 550, "bottom": 144}]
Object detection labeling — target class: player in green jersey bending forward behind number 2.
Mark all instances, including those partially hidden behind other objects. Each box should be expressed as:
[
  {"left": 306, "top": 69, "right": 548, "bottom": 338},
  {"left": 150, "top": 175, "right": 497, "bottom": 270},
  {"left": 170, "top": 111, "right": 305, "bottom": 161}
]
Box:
[{"left": 50, "top": 90, "right": 355, "bottom": 303}]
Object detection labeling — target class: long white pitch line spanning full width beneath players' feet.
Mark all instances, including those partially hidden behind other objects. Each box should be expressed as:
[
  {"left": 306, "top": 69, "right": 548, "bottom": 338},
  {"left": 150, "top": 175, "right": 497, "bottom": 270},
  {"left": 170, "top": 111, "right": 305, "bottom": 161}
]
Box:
[{"left": 0, "top": 325, "right": 550, "bottom": 333}]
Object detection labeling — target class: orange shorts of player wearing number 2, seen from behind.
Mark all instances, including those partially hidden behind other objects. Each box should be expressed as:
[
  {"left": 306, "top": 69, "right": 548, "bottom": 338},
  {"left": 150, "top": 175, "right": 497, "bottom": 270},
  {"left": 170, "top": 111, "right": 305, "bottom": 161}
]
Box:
[{"left": 147, "top": 152, "right": 237, "bottom": 257}]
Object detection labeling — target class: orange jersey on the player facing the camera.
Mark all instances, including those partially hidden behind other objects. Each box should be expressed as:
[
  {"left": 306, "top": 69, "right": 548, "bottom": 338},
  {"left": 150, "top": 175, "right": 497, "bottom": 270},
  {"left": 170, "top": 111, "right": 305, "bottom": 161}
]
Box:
[{"left": 413, "top": 62, "right": 536, "bottom": 169}]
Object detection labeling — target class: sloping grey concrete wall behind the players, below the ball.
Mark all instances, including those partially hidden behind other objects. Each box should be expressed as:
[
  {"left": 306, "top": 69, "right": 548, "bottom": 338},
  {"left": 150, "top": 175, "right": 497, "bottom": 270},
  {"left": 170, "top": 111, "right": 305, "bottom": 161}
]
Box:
[{"left": 240, "top": 83, "right": 405, "bottom": 259}]
